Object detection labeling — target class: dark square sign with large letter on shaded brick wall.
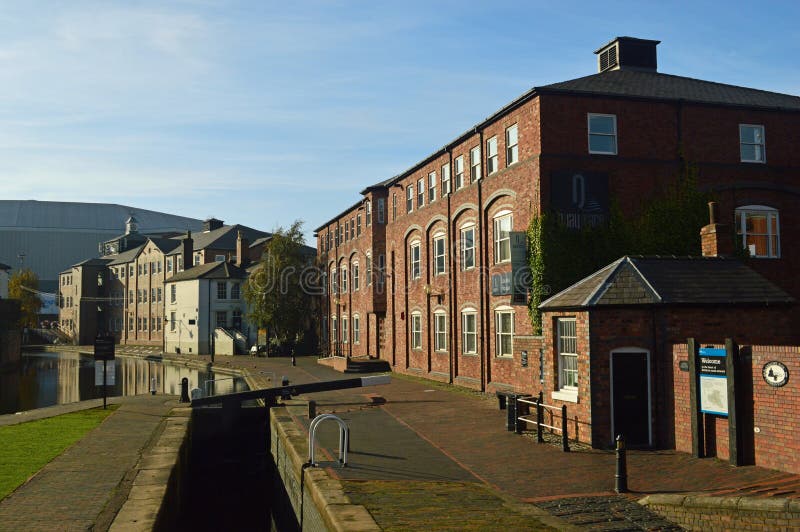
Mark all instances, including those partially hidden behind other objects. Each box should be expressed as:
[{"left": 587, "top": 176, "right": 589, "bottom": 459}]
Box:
[{"left": 550, "top": 170, "right": 609, "bottom": 229}]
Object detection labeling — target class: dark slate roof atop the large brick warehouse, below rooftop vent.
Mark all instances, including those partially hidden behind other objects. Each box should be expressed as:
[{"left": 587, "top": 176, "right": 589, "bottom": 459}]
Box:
[{"left": 537, "top": 70, "right": 800, "bottom": 111}]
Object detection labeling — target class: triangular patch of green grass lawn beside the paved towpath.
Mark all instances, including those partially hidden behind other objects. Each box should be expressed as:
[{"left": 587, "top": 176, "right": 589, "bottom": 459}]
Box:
[{"left": 0, "top": 405, "right": 117, "bottom": 499}]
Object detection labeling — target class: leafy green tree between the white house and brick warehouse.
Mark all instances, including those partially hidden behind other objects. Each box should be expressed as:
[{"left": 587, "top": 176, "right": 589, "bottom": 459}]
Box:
[{"left": 244, "top": 220, "right": 316, "bottom": 349}]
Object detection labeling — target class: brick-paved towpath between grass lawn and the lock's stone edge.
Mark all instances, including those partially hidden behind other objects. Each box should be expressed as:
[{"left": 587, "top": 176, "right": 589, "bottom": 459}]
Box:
[{"left": 0, "top": 396, "right": 177, "bottom": 531}]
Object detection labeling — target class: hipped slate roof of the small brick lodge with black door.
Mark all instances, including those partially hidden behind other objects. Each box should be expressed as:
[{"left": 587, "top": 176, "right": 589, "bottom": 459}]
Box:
[{"left": 539, "top": 256, "right": 795, "bottom": 310}]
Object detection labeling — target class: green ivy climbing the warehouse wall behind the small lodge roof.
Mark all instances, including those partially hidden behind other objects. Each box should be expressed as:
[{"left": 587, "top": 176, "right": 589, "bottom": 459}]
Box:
[{"left": 528, "top": 171, "right": 711, "bottom": 334}]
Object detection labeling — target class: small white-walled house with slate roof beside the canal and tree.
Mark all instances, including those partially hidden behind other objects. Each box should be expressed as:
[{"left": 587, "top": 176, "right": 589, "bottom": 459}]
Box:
[{"left": 164, "top": 262, "right": 257, "bottom": 355}]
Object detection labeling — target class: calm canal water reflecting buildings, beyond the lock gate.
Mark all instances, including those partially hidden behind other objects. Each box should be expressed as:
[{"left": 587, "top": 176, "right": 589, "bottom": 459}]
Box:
[{"left": 0, "top": 352, "right": 248, "bottom": 415}]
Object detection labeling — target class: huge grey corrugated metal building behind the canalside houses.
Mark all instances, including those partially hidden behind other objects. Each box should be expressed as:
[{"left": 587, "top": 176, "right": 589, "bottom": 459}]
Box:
[{"left": 0, "top": 200, "right": 203, "bottom": 287}]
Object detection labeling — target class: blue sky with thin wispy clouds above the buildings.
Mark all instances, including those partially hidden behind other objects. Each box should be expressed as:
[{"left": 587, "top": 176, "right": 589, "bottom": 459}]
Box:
[{"left": 0, "top": 0, "right": 800, "bottom": 245}]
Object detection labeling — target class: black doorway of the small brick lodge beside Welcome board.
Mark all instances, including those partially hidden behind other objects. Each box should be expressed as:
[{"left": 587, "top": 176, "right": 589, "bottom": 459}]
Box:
[{"left": 611, "top": 351, "right": 651, "bottom": 447}]
